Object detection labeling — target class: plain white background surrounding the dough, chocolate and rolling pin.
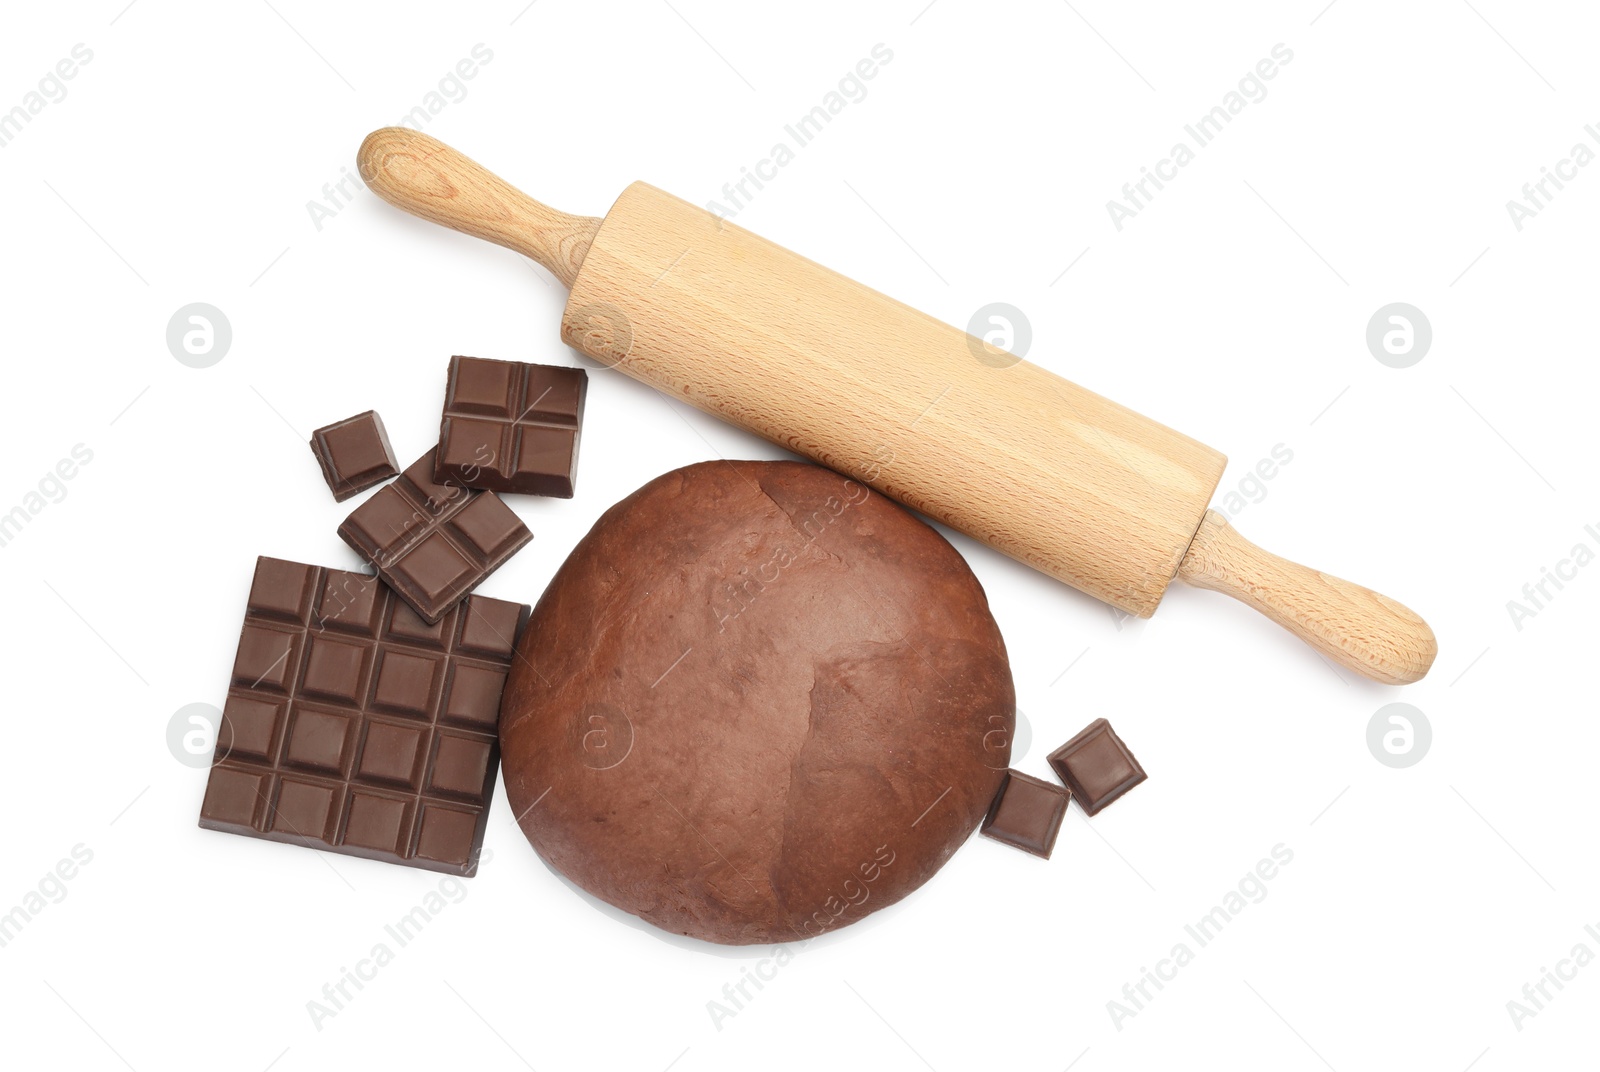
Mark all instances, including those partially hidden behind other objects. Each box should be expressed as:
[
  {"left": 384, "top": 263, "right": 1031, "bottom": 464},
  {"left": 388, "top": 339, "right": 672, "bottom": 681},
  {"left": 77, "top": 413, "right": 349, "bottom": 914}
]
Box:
[{"left": 0, "top": 0, "right": 1600, "bottom": 1072}]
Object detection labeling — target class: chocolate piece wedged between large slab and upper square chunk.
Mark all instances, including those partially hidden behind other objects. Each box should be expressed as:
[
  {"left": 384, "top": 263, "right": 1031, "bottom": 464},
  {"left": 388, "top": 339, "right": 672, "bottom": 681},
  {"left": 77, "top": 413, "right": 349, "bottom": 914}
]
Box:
[{"left": 339, "top": 451, "right": 533, "bottom": 622}]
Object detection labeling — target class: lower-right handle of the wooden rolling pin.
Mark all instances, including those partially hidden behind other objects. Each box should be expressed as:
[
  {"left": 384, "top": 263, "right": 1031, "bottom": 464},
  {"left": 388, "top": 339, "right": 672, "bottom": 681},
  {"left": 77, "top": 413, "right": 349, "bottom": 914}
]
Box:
[{"left": 1178, "top": 510, "right": 1438, "bottom": 685}]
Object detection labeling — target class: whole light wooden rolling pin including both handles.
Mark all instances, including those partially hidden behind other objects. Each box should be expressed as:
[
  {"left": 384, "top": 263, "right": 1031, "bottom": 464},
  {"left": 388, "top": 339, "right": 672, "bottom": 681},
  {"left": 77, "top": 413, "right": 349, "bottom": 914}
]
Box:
[{"left": 357, "top": 126, "right": 1437, "bottom": 685}]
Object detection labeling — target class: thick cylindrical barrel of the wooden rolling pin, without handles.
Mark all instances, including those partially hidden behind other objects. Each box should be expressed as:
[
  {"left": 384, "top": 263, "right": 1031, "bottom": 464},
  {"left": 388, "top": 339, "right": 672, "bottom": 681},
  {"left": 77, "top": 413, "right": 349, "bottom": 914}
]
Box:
[{"left": 562, "top": 182, "right": 1227, "bottom": 616}]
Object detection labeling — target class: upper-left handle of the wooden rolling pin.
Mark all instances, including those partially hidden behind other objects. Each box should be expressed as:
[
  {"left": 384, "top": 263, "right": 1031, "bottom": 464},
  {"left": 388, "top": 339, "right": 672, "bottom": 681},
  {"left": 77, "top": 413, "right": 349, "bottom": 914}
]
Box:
[{"left": 355, "top": 126, "right": 600, "bottom": 286}]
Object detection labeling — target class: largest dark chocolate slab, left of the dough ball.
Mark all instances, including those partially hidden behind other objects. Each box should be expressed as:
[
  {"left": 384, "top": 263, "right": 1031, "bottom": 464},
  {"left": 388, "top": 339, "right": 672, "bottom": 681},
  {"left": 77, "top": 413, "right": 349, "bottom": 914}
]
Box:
[{"left": 200, "top": 558, "right": 528, "bottom": 875}]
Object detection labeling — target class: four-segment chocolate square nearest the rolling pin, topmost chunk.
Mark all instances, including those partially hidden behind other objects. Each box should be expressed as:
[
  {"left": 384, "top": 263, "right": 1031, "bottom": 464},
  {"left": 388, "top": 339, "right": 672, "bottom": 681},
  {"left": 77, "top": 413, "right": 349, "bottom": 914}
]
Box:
[{"left": 434, "top": 357, "right": 589, "bottom": 499}]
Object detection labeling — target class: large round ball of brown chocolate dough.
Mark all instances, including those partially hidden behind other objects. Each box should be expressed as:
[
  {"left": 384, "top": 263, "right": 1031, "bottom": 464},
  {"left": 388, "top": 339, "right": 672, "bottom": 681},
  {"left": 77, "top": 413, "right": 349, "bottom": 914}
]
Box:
[{"left": 499, "top": 461, "right": 1014, "bottom": 944}]
